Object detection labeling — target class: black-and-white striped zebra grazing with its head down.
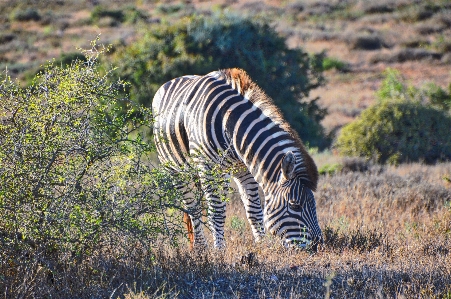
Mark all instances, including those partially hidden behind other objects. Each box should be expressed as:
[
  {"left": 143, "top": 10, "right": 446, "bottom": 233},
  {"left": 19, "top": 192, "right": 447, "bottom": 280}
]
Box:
[{"left": 152, "top": 69, "right": 322, "bottom": 250}]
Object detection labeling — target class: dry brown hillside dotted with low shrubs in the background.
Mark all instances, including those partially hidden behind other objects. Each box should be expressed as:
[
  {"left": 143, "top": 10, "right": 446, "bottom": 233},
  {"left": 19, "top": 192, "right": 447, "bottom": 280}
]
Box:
[{"left": 0, "top": 0, "right": 451, "bottom": 135}]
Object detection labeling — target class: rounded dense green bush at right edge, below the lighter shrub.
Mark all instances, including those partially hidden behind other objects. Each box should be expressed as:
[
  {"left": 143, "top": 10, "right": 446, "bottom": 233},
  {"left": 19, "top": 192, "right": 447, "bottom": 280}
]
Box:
[{"left": 336, "top": 100, "right": 451, "bottom": 164}]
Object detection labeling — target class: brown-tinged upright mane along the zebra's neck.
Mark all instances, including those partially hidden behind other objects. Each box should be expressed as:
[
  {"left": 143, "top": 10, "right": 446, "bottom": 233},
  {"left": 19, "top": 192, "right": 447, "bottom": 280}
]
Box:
[{"left": 219, "top": 68, "right": 318, "bottom": 191}]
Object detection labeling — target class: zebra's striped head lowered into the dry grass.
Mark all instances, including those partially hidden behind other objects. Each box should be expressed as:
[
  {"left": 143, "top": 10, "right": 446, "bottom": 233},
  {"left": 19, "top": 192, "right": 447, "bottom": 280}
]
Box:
[{"left": 265, "top": 152, "right": 323, "bottom": 251}]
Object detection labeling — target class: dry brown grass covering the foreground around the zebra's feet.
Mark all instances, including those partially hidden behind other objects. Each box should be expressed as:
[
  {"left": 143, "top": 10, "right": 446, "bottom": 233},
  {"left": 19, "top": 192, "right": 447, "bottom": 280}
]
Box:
[{"left": 0, "top": 163, "right": 451, "bottom": 299}]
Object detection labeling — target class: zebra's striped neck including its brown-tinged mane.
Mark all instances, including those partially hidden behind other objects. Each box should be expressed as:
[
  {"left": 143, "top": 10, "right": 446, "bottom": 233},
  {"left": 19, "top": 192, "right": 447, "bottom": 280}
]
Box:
[{"left": 208, "top": 69, "right": 318, "bottom": 193}]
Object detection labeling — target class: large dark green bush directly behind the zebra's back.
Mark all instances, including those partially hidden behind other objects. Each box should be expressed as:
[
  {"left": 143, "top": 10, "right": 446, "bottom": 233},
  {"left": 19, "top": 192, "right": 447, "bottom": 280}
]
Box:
[{"left": 109, "top": 15, "right": 326, "bottom": 147}]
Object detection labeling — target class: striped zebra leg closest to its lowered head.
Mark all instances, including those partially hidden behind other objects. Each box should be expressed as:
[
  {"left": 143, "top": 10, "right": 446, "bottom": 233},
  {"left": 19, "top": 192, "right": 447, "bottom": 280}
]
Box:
[{"left": 233, "top": 171, "right": 265, "bottom": 242}]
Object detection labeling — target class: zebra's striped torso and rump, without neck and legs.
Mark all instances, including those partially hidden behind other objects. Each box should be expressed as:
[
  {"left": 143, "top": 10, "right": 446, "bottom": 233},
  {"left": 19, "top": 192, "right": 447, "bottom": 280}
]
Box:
[{"left": 152, "top": 72, "right": 244, "bottom": 170}]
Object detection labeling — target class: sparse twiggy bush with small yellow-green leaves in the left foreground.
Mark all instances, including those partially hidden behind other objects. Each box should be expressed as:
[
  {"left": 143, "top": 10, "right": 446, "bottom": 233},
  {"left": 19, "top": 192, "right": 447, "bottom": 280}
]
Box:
[{"left": 0, "top": 42, "right": 189, "bottom": 278}]
